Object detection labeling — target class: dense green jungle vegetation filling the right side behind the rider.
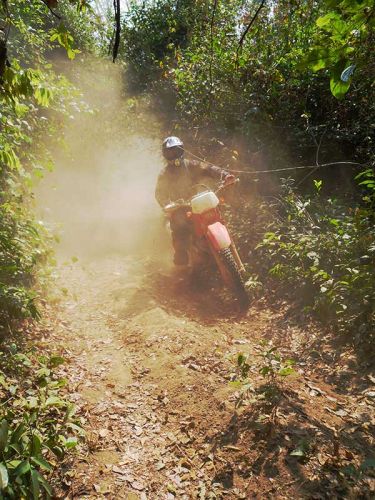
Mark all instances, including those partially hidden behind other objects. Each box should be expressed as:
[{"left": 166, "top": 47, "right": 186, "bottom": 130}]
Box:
[{"left": 119, "top": 0, "right": 375, "bottom": 343}]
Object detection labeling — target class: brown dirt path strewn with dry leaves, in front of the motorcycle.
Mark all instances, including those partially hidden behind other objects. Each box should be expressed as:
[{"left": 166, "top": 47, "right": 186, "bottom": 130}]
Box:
[{"left": 37, "top": 257, "right": 374, "bottom": 499}]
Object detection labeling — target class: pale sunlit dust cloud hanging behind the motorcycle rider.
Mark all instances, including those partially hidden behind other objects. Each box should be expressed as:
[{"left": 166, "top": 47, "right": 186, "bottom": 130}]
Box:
[{"left": 36, "top": 61, "right": 170, "bottom": 259}]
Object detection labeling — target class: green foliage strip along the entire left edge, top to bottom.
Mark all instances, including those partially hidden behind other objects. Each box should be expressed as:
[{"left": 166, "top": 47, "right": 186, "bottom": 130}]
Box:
[{"left": 0, "top": 0, "right": 99, "bottom": 499}]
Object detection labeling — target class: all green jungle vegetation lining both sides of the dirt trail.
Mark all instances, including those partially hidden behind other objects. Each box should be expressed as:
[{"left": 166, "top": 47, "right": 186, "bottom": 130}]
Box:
[{"left": 0, "top": 0, "right": 375, "bottom": 498}]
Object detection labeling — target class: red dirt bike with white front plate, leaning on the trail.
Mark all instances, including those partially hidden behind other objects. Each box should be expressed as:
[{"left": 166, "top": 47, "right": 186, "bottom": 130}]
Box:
[{"left": 164, "top": 179, "right": 248, "bottom": 305}]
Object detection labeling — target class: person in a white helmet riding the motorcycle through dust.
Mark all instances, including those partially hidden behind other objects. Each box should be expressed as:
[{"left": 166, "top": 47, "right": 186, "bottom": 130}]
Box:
[{"left": 155, "top": 136, "right": 234, "bottom": 266}]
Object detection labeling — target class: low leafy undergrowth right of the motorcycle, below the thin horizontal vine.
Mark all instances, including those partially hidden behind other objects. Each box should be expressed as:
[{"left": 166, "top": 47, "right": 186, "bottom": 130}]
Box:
[{"left": 254, "top": 175, "right": 375, "bottom": 344}]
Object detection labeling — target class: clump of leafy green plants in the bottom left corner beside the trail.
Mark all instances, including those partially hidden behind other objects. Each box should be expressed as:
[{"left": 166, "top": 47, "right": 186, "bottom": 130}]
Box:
[{"left": 0, "top": 343, "right": 84, "bottom": 499}]
